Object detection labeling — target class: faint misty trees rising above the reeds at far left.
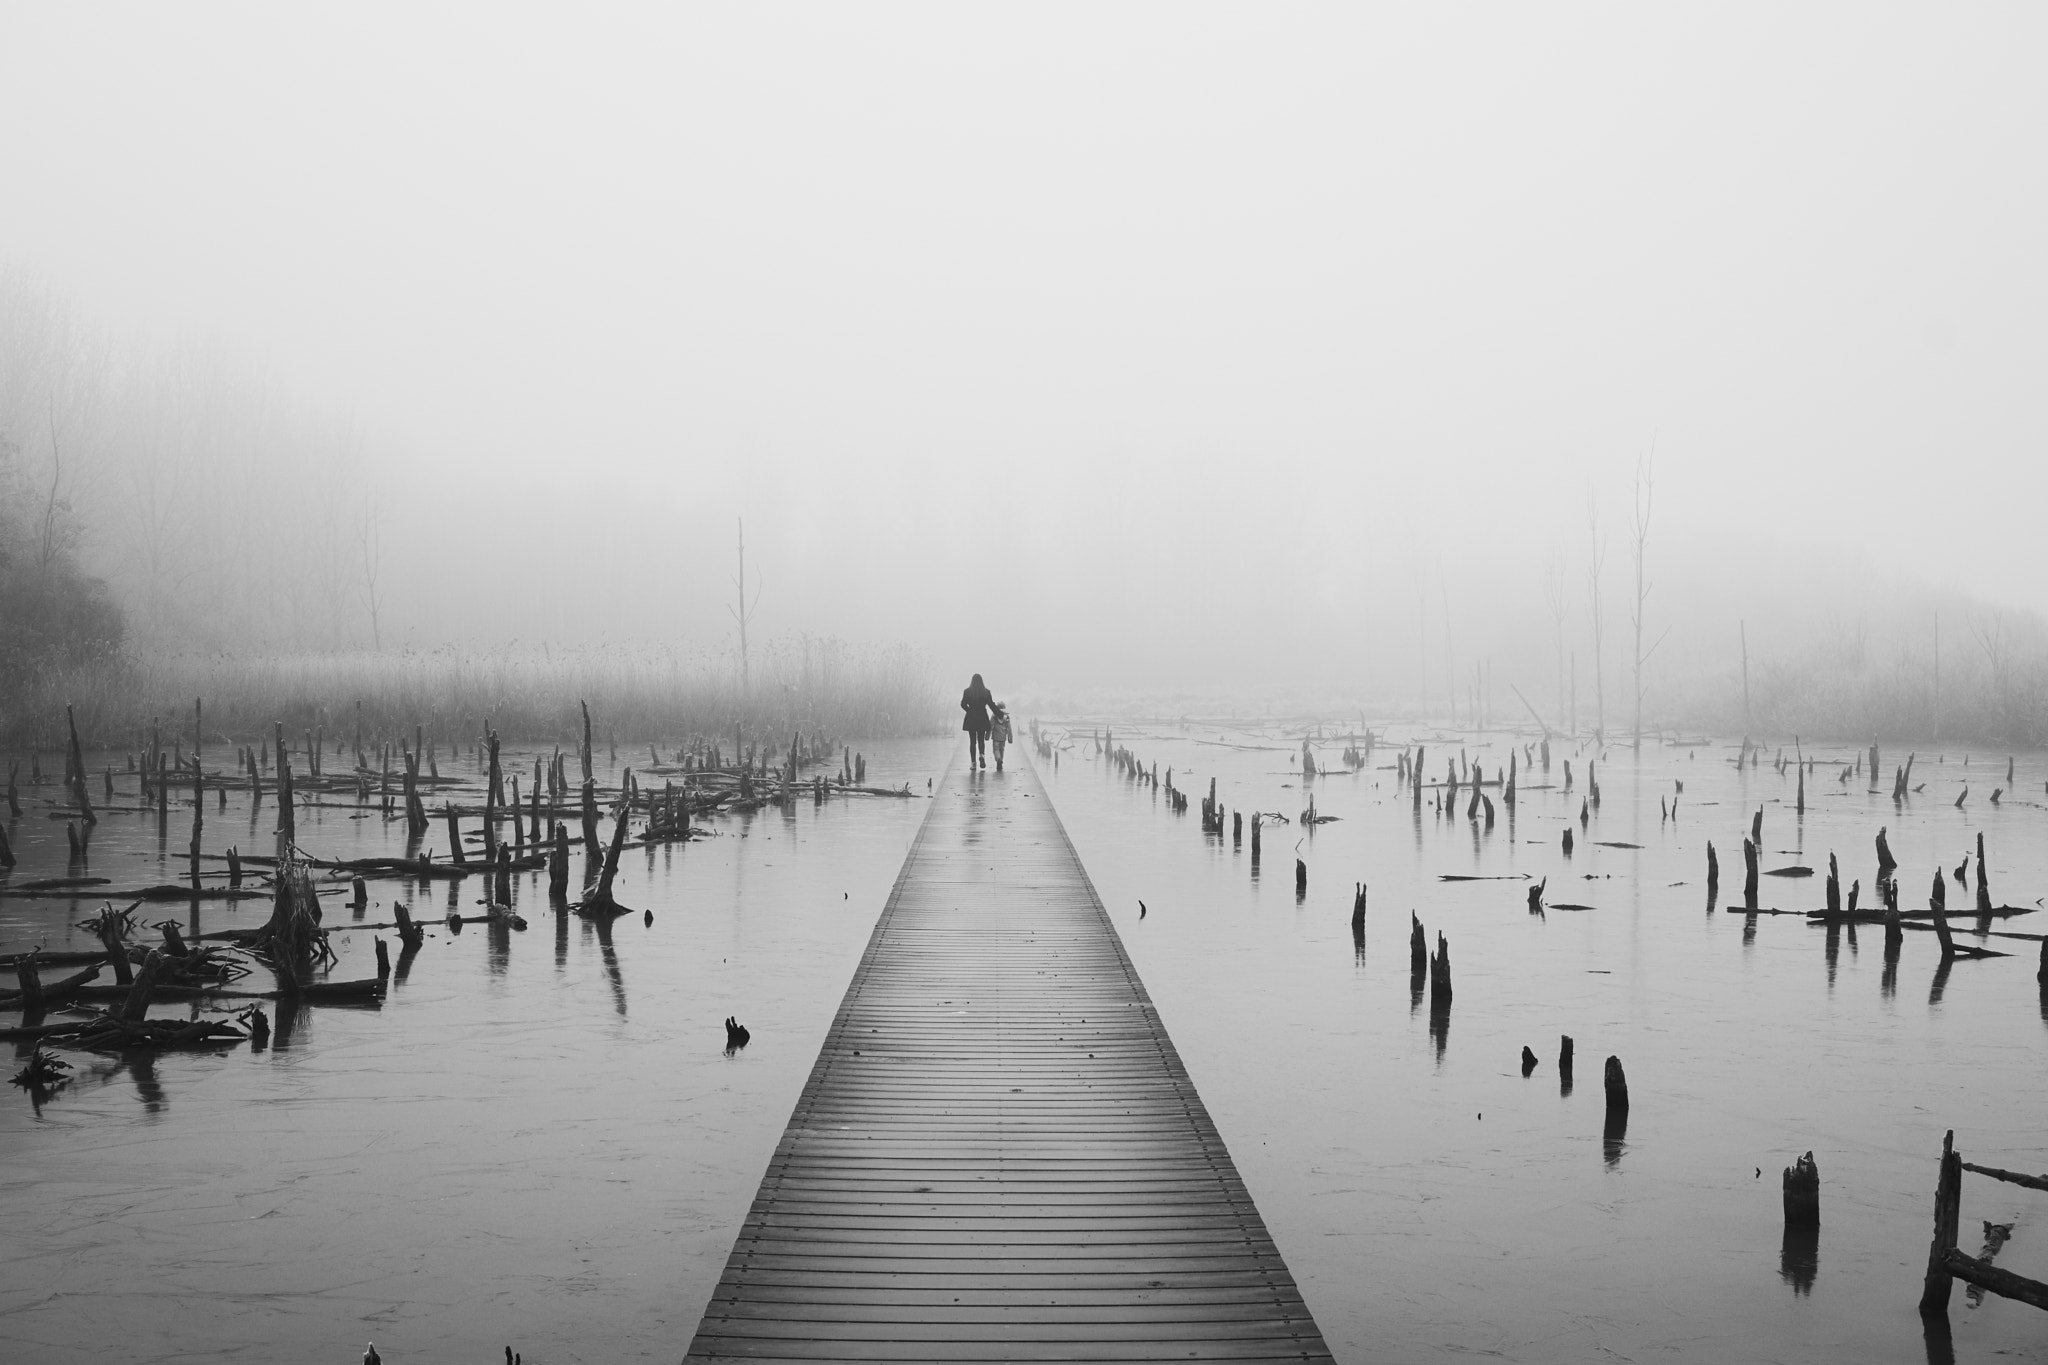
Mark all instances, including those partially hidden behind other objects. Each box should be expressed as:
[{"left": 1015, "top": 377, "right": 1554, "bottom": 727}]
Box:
[{"left": 0, "top": 268, "right": 375, "bottom": 649}]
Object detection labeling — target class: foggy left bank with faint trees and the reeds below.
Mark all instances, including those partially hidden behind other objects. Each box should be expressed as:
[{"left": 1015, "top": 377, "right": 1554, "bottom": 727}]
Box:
[{"left": 0, "top": 266, "right": 946, "bottom": 745}]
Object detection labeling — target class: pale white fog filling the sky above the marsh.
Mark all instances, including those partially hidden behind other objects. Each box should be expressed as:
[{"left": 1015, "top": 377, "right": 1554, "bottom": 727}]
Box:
[{"left": 0, "top": 4, "right": 2048, "bottom": 712}]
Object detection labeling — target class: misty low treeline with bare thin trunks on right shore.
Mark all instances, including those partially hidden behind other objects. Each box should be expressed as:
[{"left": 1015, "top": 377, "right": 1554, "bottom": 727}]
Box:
[{"left": 1409, "top": 458, "right": 2048, "bottom": 747}]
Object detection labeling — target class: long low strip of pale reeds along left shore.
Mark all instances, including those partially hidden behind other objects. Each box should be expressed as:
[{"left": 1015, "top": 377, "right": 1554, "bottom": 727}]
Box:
[{"left": 0, "top": 636, "right": 948, "bottom": 749}]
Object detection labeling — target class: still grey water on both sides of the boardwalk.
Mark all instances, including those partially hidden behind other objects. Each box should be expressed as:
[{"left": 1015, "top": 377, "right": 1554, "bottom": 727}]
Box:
[{"left": 0, "top": 722, "right": 2048, "bottom": 1365}]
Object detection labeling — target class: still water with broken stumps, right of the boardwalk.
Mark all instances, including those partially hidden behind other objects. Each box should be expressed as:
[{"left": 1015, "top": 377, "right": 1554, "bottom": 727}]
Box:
[{"left": 1049, "top": 726, "right": 2048, "bottom": 1365}]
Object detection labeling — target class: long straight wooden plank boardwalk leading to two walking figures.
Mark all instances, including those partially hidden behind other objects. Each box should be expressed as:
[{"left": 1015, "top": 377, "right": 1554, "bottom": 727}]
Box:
[{"left": 690, "top": 753, "right": 1329, "bottom": 1361}]
